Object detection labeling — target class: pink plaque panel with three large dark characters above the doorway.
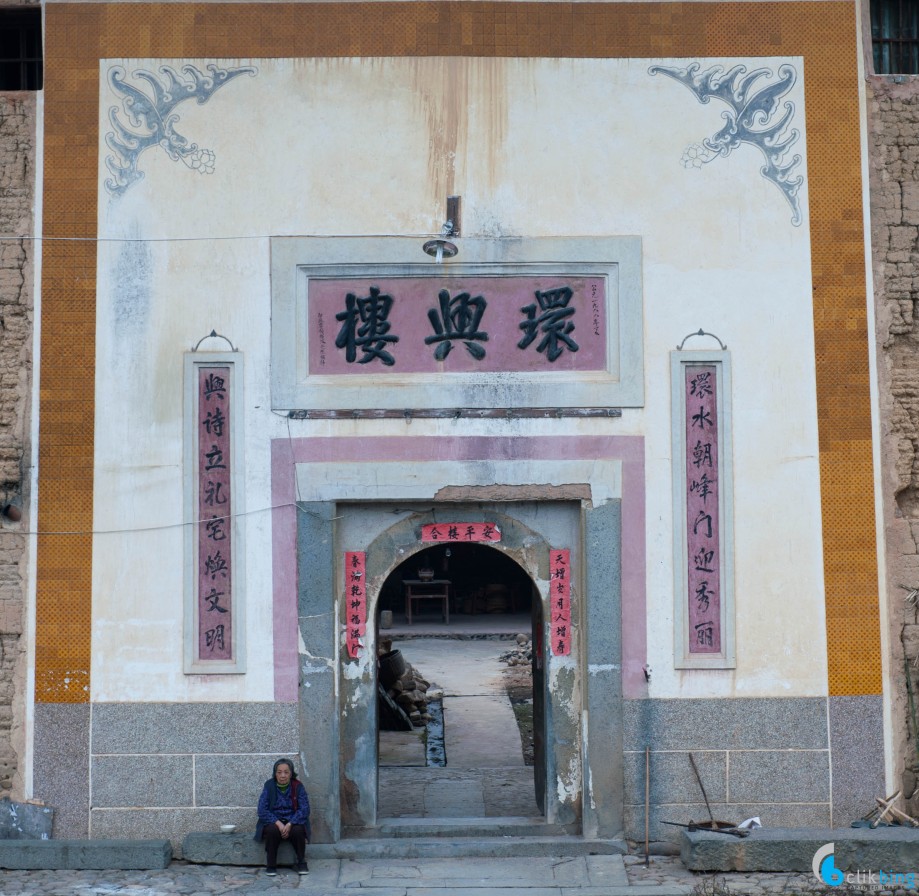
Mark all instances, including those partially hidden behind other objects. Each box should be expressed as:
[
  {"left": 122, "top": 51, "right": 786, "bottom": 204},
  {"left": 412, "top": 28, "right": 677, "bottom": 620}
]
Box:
[{"left": 308, "top": 275, "right": 607, "bottom": 375}]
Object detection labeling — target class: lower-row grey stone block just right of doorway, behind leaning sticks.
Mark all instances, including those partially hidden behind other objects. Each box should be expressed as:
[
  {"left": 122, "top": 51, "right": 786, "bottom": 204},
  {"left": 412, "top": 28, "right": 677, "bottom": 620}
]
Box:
[{"left": 624, "top": 750, "right": 727, "bottom": 805}]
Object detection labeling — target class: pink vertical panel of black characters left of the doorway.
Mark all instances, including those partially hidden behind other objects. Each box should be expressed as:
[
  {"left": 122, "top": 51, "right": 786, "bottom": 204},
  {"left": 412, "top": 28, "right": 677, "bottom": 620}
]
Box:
[{"left": 195, "top": 366, "right": 233, "bottom": 662}]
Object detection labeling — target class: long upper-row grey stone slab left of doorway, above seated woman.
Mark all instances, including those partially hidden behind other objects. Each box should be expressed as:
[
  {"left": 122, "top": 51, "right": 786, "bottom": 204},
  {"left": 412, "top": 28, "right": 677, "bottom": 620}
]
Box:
[{"left": 92, "top": 703, "right": 299, "bottom": 756}]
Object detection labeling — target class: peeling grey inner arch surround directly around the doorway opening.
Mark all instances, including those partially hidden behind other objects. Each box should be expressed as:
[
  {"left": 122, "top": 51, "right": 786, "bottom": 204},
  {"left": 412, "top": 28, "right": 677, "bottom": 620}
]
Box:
[{"left": 336, "top": 501, "right": 584, "bottom": 835}]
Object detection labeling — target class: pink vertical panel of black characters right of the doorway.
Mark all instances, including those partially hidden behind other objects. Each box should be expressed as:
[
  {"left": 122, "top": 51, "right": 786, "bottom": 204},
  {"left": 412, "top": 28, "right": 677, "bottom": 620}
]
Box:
[{"left": 684, "top": 365, "right": 721, "bottom": 654}]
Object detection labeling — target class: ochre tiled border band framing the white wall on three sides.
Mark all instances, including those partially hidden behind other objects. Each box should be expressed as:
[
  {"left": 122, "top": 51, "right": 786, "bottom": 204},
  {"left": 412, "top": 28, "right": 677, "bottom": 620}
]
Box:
[{"left": 35, "top": 0, "right": 881, "bottom": 703}]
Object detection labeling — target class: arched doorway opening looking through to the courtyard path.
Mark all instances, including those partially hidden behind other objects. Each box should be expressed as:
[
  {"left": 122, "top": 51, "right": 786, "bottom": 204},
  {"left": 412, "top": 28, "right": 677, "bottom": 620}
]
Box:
[{"left": 376, "top": 542, "right": 545, "bottom": 821}]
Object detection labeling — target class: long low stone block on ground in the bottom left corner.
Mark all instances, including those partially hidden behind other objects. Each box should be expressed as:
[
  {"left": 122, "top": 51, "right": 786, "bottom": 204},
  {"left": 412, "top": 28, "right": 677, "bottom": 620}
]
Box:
[{"left": 0, "top": 840, "right": 172, "bottom": 871}]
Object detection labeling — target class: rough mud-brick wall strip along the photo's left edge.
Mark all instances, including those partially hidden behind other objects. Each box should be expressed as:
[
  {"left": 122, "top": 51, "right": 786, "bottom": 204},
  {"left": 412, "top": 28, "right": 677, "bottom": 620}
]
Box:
[{"left": 0, "top": 93, "right": 36, "bottom": 795}]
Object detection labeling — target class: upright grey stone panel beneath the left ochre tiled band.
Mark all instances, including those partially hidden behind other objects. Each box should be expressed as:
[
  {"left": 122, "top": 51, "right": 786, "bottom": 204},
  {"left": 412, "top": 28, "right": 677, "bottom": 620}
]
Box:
[{"left": 33, "top": 703, "right": 90, "bottom": 839}]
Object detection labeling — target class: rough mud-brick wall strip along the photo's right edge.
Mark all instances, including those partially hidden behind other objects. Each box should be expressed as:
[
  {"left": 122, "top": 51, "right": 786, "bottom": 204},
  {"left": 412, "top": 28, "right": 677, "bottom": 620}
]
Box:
[{"left": 868, "top": 76, "right": 919, "bottom": 815}]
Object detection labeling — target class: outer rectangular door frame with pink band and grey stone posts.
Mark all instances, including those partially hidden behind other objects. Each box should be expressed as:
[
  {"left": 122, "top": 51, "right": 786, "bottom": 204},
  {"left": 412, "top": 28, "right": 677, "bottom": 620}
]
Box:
[{"left": 282, "top": 437, "right": 645, "bottom": 842}]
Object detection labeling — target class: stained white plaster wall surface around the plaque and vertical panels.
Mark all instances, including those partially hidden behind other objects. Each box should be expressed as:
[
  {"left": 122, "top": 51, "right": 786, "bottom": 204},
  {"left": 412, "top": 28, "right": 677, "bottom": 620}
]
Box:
[{"left": 92, "top": 58, "right": 826, "bottom": 700}]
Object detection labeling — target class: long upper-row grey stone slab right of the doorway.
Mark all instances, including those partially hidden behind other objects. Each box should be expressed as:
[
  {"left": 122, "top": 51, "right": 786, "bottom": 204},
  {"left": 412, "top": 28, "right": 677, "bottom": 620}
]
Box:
[{"left": 623, "top": 697, "right": 828, "bottom": 753}]
